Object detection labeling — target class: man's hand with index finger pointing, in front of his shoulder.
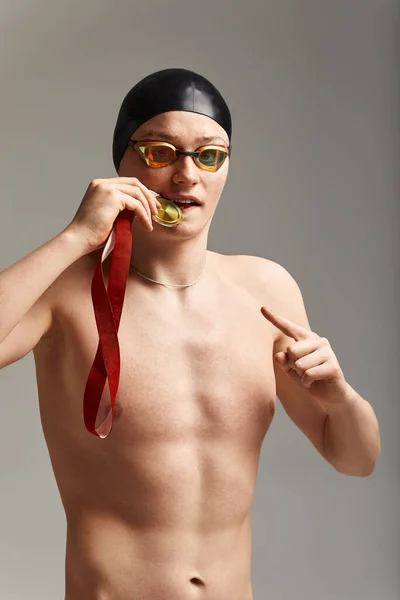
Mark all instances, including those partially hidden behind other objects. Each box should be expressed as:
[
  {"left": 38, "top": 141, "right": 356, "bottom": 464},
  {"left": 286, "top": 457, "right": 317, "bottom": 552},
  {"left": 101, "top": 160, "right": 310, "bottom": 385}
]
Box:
[{"left": 261, "top": 306, "right": 350, "bottom": 408}]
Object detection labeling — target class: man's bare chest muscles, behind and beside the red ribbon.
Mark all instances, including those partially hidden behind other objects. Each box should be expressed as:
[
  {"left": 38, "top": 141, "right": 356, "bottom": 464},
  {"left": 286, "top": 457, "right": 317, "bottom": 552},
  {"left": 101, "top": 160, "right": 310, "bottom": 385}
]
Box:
[{"left": 35, "top": 274, "right": 276, "bottom": 442}]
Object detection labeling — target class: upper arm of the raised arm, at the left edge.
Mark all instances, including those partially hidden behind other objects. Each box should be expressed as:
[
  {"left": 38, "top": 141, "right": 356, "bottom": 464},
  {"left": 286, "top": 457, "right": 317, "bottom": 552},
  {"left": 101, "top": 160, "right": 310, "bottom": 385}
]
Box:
[{"left": 0, "top": 293, "right": 52, "bottom": 369}]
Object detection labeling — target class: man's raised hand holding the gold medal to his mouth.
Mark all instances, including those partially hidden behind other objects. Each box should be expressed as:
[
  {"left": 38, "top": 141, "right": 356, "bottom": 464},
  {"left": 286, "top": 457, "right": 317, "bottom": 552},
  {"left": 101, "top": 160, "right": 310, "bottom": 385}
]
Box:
[{"left": 66, "top": 177, "right": 161, "bottom": 253}]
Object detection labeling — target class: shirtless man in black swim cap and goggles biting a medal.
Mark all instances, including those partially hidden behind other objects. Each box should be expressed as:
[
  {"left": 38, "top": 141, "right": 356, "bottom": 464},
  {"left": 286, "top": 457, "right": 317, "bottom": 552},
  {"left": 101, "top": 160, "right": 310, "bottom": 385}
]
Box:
[{"left": 0, "top": 70, "right": 380, "bottom": 600}]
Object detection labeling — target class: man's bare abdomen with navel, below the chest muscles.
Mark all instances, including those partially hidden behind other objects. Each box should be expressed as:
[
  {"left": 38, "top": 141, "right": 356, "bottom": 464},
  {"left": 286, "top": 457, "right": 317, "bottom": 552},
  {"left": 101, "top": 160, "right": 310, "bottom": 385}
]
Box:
[{"left": 57, "top": 424, "right": 255, "bottom": 600}]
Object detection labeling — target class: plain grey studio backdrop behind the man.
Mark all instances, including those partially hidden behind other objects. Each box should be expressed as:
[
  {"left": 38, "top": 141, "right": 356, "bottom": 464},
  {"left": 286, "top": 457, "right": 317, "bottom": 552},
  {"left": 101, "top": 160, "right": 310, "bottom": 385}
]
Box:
[{"left": 0, "top": 0, "right": 400, "bottom": 600}]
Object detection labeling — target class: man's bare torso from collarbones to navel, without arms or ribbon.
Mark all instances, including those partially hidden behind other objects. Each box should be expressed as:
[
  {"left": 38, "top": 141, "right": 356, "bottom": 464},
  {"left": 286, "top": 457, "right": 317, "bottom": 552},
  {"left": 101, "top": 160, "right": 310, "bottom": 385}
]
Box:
[{"left": 34, "top": 252, "right": 277, "bottom": 600}]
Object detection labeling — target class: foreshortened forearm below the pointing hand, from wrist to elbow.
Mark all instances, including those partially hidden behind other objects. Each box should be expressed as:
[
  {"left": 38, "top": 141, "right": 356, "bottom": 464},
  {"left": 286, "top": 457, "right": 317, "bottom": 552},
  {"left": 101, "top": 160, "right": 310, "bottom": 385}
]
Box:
[{"left": 324, "top": 385, "right": 381, "bottom": 477}]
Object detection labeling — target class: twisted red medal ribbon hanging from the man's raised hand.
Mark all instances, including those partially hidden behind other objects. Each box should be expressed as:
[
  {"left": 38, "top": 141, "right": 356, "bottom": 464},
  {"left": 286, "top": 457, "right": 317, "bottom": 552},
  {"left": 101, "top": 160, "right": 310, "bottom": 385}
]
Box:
[{"left": 83, "top": 210, "right": 134, "bottom": 438}]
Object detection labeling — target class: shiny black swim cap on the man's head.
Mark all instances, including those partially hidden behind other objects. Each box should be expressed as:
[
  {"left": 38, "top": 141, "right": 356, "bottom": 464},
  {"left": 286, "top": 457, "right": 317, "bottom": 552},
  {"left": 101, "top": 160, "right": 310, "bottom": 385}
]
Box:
[{"left": 113, "top": 69, "right": 232, "bottom": 172}]
